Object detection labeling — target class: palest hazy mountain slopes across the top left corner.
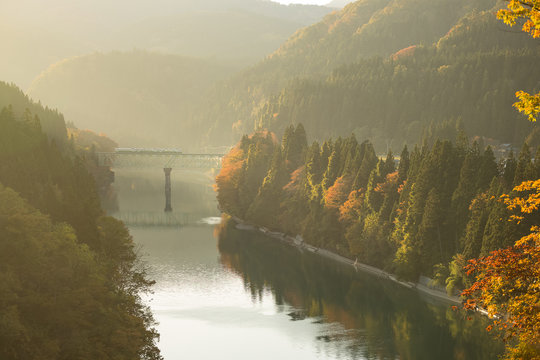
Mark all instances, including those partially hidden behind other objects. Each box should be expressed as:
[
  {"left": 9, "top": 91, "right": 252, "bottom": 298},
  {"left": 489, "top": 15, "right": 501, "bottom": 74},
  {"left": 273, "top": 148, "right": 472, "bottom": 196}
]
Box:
[{"left": 0, "top": 0, "right": 331, "bottom": 88}]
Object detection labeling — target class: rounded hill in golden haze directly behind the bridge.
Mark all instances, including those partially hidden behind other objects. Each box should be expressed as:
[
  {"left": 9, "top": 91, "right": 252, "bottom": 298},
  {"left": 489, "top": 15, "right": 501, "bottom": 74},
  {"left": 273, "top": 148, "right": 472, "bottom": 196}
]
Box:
[{"left": 28, "top": 51, "right": 232, "bottom": 149}]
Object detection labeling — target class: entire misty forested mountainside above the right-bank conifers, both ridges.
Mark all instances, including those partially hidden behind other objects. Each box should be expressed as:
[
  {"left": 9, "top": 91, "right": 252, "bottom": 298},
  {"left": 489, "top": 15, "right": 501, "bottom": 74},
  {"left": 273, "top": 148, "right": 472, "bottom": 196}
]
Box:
[{"left": 196, "top": 2, "right": 539, "bottom": 148}]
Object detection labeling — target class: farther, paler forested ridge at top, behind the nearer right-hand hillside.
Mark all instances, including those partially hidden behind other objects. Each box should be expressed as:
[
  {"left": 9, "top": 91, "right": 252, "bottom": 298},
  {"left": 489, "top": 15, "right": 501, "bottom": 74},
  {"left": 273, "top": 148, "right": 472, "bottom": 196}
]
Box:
[{"left": 261, "top": 0, "right": 493, "bottom": 76}]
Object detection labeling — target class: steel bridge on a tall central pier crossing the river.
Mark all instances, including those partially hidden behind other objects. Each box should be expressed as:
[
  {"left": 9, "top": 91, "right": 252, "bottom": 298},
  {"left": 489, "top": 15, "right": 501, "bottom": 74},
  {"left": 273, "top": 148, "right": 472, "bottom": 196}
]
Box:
[{"left": 97, "top": 148, "right": 224, "bottom": 214}]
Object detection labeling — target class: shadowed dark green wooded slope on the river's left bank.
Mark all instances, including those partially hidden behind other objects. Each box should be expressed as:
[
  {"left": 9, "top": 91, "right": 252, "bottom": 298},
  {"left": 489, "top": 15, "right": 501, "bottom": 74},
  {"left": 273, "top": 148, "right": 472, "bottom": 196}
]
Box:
[{"left": 0, "top": 84, "right": 161, "bottom": 360}]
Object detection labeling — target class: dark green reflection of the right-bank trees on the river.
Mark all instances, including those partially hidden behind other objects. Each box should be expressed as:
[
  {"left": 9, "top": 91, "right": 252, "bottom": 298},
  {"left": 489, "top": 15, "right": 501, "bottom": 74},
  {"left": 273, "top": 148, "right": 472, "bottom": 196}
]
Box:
[{"left": 217, "top": 218, "right": 502, "bottom": 359}]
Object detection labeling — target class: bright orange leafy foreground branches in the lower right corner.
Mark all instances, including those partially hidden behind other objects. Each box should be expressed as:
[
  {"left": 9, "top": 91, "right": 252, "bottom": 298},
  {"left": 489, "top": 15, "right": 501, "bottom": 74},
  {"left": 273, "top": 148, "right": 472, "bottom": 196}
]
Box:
[{"left": 462, "top": 179, "right": 540, "bottom": 359}]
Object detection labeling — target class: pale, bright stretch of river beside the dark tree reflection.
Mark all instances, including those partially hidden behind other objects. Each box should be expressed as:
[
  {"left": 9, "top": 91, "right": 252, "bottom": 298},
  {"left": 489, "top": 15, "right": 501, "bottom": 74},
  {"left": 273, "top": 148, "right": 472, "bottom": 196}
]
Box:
[{"left": 135, "top": 226, "right": 372, "bottom": 360}]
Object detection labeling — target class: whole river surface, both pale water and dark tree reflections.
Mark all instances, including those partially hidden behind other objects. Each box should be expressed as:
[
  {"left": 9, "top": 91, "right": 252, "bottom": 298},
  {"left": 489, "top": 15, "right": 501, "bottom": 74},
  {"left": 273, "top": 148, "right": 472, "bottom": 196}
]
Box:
[{"left": 112, "top": 172, "right": 502, "bottom": 360}]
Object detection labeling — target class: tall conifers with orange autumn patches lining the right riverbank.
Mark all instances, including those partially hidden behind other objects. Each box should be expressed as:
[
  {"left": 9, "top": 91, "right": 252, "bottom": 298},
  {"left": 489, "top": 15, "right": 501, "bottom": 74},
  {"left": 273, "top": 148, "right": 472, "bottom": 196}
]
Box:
[{"left": 216, "top": 125, "right": 540, "bottom": 286}]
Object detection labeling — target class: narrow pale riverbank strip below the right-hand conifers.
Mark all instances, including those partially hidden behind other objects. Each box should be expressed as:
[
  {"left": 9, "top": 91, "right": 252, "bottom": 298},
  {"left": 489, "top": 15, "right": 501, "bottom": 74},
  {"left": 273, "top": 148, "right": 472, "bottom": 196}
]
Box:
[{"left": 231, "top": 216, "right": 462, "bottom": 304}]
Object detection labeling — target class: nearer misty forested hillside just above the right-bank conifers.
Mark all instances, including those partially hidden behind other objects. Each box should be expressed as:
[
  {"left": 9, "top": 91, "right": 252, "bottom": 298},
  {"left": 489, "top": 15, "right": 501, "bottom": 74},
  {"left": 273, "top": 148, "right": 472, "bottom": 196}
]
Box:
[{"left": 257, "top": 13, "right": 540, "bottom": 151}]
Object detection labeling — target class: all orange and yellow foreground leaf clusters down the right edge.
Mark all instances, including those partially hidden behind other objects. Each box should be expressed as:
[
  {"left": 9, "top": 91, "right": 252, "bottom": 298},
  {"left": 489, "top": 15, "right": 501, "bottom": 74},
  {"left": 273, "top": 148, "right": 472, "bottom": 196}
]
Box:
[{"left": 463, "top": 4, "right": 540, "bottom": 359}]
